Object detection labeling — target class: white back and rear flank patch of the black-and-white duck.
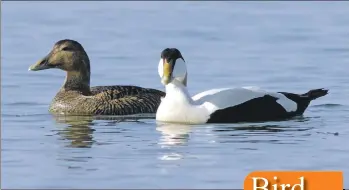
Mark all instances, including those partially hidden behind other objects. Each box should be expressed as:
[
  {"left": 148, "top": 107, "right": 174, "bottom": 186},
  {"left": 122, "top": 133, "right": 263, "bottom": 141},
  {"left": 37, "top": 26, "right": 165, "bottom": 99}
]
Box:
[{"left": 192, "top": 86, "right": 297, "bottom": 113}]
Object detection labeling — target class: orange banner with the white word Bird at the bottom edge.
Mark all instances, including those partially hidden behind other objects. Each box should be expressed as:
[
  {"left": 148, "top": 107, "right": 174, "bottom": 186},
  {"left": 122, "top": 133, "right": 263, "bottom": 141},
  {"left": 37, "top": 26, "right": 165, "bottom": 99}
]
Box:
[{"left": 244, "top": 171, "right": 343, "bottom": 190}]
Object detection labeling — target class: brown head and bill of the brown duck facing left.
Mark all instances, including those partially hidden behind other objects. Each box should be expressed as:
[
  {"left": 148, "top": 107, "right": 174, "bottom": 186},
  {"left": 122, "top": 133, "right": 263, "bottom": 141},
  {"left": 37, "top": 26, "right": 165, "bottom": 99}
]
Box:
[{"left": 29, "top": 39, "right": 90, "bottom": 75}]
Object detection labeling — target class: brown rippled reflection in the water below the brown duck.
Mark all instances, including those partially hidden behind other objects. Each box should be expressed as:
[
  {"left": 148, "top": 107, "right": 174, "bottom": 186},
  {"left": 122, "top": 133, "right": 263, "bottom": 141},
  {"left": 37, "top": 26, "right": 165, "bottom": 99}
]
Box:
[{"left": 54, "top": 116, "right": 95, "bottom": 148}]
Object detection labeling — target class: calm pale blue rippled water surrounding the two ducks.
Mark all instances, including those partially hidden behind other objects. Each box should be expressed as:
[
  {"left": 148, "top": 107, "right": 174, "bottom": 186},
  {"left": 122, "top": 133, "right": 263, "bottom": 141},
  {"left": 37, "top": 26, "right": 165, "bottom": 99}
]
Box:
[{"left": 1, "top": 2, "right": 349, "bottom": 188}]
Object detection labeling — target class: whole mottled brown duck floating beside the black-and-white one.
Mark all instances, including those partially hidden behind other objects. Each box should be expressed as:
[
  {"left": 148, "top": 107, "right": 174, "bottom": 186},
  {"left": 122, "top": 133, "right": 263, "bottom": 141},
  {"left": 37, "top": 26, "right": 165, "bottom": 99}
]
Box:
[{"left": 29, "top": 39, "right": 165, "bottom": 115}]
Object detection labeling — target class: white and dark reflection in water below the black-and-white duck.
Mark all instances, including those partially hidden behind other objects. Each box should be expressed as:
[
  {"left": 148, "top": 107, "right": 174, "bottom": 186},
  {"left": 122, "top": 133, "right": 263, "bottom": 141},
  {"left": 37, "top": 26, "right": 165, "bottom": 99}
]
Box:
[{"left": 157, "top": 117, "right": 313, "bottom": 147}]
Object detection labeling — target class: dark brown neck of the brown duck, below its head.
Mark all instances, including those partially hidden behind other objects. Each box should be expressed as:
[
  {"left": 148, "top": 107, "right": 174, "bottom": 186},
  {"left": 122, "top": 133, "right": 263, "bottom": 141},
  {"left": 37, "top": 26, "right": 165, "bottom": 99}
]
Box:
[{"left": 62, "top": 69, "right": 90, "bottom": 95}]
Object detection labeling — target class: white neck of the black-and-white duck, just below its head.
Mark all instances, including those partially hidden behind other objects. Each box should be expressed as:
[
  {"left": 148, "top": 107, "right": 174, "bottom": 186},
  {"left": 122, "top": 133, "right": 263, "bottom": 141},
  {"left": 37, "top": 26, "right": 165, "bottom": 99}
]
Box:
[{"left": 165, "top": 80, "right": 193, "bottom": 104}]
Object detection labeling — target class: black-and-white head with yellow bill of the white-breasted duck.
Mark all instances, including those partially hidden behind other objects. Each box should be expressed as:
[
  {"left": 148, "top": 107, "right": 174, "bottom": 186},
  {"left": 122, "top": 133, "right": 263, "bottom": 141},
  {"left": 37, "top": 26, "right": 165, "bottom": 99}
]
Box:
[{"left": 158, "top": 48, "right": 187, "bottom": 86}]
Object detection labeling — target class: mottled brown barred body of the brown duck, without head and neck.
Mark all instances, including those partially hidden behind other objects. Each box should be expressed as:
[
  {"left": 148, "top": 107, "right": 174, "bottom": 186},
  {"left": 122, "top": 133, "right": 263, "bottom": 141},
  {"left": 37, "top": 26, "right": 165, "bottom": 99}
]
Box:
[{"left": 50, "top": 86, "right": 165, "bottom": 115}]
